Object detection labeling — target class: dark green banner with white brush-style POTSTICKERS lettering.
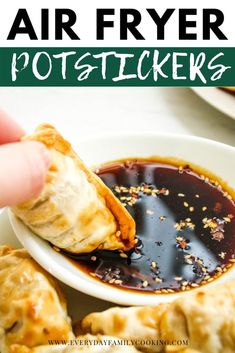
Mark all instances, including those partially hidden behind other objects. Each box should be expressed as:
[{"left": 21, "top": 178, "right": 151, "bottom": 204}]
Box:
[{"left": 0, "top": 47, "right": 235, "bottom": 86}]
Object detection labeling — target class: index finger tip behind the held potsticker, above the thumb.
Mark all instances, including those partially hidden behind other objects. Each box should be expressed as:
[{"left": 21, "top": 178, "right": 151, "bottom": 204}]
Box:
[{"left": 0, "top": 110, "right": 25, "bottom": 144}]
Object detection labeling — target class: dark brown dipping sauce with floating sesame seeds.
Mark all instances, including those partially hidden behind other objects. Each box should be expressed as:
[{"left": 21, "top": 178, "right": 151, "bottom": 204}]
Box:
[{"left": 63, "top": 160, "right": 235, "bottom": 293}]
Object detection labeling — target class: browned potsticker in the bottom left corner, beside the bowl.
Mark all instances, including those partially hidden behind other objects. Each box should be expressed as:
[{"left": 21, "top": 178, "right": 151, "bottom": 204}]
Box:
[{"left": 0, "top": 246, "right": 74, "bottom": 353}]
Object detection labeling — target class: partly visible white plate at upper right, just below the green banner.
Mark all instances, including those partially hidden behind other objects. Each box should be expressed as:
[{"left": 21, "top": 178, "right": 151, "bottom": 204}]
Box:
[{"left": 191, "top": 87, "right": 235, "bottom": 119}]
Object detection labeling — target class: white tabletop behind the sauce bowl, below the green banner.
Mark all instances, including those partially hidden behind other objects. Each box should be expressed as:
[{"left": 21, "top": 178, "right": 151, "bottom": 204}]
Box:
[{"left": 0, "top": 87, "right": 235, "bottom": 148}]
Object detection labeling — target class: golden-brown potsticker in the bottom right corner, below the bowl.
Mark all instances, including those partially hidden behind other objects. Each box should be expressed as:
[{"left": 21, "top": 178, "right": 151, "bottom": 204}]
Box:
[{"left": 161, "top": 281, "right": 235, "bottom": 353}]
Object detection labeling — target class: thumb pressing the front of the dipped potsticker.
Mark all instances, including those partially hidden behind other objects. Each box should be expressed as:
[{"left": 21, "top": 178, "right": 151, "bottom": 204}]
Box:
[{"left": 0, "top": 141, "right": 50, "bottom": 207}]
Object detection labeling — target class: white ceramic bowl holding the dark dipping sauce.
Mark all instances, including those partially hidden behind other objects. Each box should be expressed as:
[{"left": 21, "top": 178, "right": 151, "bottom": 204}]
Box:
[{"left": 9, "top": 133, "right": 235, "bottom": 305}]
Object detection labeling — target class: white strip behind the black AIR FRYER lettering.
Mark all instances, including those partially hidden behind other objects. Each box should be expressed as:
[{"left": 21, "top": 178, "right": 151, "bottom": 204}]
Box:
[{"left": 0, "top": 0, "right": 235, "bottom": 47}]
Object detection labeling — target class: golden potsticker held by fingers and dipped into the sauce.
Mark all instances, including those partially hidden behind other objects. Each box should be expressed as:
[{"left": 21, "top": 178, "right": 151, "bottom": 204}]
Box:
[{"left": 12, "top": 125, "right": 135, "bottom": 253}]
